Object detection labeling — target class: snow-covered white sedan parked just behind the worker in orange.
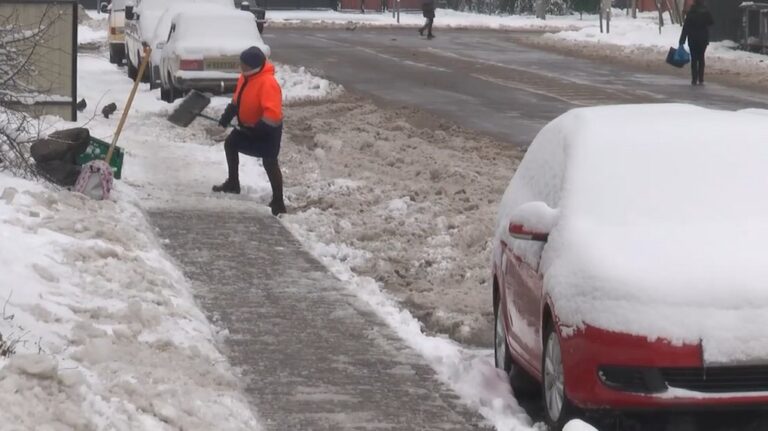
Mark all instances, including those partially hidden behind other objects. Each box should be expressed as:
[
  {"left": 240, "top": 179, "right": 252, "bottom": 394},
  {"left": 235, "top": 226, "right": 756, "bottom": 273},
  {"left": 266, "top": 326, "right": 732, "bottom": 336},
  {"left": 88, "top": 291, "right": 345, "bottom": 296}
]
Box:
[{"left": 160, "top": 5, "right": 271, "bottom": 102}]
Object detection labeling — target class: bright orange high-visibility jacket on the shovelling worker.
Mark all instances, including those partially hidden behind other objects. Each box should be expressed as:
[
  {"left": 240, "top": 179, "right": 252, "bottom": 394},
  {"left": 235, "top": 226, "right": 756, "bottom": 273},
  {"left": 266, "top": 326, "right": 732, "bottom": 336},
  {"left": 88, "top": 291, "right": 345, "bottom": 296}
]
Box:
[{"left": 232, "top": 62, "right": 283, "bottom": 127}]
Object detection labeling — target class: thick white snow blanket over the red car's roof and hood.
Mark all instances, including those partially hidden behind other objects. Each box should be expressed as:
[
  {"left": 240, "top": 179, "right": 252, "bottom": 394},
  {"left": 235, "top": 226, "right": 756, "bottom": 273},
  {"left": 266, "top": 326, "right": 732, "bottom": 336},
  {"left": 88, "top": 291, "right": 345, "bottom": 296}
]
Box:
[{"left": 500, "top": 104, "right": 768, "bottom": 363}]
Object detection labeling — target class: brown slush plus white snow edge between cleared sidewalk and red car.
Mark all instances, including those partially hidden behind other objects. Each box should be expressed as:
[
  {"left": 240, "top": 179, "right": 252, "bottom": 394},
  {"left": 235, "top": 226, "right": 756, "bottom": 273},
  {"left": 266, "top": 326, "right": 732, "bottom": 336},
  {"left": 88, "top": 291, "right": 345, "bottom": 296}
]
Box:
[{"left": 281, "top": 97, "right": 535, "bottom": 431}]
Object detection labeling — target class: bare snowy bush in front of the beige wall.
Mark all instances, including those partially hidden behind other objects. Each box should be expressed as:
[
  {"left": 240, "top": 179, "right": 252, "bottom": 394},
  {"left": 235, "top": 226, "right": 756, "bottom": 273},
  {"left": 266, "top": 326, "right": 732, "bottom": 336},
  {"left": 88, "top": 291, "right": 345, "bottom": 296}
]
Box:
[{"left": 0, "top": 8, "right": 60, "bottom": 177}]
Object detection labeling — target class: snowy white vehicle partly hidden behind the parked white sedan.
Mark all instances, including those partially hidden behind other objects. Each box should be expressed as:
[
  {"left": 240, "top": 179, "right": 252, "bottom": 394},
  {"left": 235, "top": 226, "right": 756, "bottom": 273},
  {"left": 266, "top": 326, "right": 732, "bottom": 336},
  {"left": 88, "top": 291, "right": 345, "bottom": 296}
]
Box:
[{"left": 125, "top": 0, "right": 234, "bottom": 88}]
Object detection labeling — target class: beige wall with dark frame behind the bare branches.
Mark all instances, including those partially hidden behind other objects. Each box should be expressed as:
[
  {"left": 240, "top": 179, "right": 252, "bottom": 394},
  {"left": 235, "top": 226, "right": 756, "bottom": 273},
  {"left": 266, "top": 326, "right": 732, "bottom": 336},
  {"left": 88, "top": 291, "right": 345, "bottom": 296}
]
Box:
[{"left": 0, "top": 0, "right": 77, "bottom": 121}]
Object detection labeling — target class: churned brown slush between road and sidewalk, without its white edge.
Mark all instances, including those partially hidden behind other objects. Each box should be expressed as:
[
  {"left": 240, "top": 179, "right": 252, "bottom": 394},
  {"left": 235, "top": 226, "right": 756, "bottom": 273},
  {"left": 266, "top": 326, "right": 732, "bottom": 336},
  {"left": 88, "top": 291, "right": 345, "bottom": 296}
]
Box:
[{"left": 281, "top": 96, "right": 522, "bottom": 346}]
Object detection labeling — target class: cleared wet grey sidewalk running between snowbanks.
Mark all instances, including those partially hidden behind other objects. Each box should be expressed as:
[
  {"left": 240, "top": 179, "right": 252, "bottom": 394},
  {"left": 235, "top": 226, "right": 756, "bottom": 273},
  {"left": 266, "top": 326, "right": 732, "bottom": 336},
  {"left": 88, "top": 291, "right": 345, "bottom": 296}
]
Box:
[{"left": 150, "top": 209, "right": 491, "bottom": 431}]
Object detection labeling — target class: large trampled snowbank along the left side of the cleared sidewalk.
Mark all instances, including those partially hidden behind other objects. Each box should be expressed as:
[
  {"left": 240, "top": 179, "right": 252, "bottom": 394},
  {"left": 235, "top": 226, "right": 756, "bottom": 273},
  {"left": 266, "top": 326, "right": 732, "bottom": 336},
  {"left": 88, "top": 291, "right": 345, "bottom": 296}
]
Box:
[{"left": 0, "top": 174, "right": 258, "bottom": 430}]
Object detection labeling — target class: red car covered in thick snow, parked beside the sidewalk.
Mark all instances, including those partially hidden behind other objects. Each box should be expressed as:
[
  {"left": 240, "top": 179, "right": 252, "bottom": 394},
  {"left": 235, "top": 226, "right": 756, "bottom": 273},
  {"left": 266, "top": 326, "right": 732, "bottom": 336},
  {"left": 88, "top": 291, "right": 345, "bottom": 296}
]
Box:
[{"left": 492, "top": 105, "right": 768, "bottom": 430}]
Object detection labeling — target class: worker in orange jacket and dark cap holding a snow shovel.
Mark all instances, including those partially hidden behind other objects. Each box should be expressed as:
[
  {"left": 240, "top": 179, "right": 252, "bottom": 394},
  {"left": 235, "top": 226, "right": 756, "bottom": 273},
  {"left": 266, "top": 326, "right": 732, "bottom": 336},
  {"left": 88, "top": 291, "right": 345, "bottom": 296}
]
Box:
[{"left": 213, "top": 46, "right": 286, "bottom": 215}]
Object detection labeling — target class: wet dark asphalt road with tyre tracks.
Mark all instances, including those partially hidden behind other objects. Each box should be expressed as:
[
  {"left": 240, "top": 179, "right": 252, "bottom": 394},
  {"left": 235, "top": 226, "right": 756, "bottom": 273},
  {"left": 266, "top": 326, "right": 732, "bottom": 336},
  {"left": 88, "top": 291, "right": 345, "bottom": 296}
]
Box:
[{"left": 264, "top": 28, "right": 768, "bottom": 146}]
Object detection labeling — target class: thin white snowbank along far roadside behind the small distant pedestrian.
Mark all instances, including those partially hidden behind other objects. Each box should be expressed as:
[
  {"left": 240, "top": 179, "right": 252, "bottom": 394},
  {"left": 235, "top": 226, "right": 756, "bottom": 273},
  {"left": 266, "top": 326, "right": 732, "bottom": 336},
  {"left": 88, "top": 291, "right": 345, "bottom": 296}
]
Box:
[{"left": 267, "top": 9, "right": 591, "bottom": 31}]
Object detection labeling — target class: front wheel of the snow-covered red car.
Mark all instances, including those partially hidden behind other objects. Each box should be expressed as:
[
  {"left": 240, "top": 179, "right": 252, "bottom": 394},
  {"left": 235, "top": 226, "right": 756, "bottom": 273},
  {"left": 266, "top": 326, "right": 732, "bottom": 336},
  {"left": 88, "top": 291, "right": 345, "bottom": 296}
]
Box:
[{"left": 541, "top": 323, "right": 577, "bottom": 431}]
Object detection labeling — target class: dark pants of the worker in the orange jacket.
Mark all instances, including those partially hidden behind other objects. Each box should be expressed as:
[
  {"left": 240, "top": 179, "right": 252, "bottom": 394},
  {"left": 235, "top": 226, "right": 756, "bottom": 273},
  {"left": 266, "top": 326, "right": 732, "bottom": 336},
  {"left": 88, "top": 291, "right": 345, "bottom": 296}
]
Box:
[{"left": 224, "top": 124, "right": 283, "bottom": 203}]
